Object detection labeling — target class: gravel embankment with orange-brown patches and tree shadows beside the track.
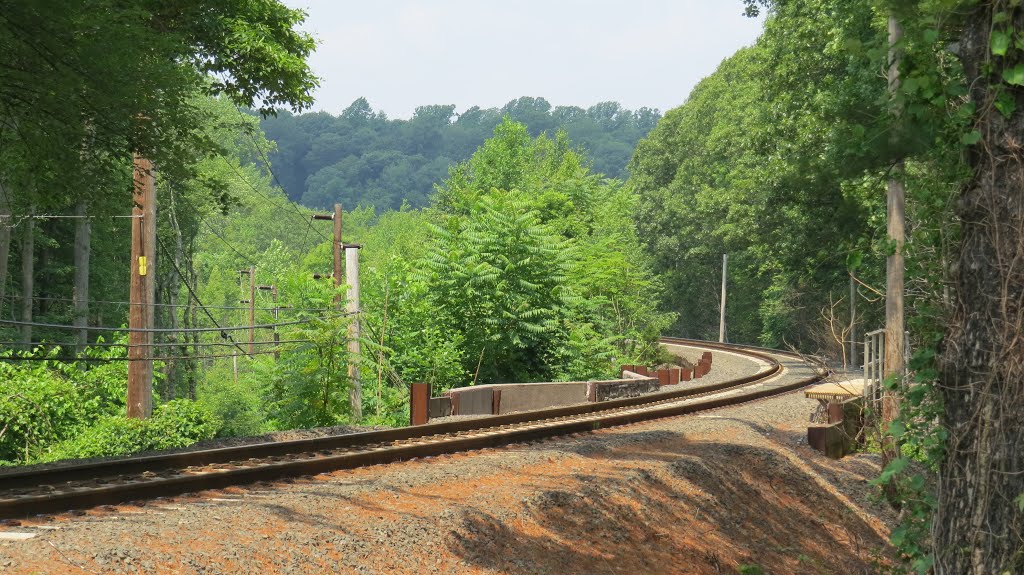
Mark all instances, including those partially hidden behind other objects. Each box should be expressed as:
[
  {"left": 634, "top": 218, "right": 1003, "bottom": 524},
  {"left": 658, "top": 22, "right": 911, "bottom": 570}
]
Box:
[{"left": 0, "top": 347, "right": 893, "bottom": 574}]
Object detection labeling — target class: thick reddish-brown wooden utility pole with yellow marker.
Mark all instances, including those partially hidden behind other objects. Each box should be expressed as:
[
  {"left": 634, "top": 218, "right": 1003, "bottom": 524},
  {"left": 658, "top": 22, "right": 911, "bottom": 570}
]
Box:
[{"left": 127, "top": 153, "right": 157, "bottom": 418}]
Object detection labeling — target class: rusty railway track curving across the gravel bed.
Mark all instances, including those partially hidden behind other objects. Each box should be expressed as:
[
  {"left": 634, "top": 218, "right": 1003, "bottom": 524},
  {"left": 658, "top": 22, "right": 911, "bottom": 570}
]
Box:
[{"left": 0, "top": 338, "right": 818, "bottom": 519}]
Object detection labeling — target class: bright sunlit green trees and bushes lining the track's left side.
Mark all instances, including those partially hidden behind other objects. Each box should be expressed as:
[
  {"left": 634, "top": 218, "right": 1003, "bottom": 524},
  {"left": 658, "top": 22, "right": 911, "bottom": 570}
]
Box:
[{"left": 0, "top": 109, "right": 671, "bottom": 461}]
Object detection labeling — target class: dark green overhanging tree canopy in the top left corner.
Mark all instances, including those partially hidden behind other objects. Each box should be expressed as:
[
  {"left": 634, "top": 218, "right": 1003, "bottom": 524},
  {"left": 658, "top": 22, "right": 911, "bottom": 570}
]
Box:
[{"left": 0, "top": 0, "right": 317, "bottom": 207}]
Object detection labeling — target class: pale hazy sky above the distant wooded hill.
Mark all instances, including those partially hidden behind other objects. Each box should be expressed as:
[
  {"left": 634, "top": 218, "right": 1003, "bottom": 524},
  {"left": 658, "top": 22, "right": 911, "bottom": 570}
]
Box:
[{"left": 285, "top": 0, "right": 762, "bottom": 118}]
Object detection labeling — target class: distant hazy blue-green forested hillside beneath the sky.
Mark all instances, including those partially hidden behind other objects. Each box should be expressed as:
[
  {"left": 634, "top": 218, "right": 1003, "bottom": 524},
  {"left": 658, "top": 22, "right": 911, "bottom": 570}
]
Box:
[{"left": 262, "top": 97, "right": 660, "bottom": 210}]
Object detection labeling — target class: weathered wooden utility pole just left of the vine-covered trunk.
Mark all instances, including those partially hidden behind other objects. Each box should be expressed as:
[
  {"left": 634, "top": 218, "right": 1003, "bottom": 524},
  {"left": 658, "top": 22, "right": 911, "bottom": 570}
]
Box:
[{"left": 882, "top": 14, "right": 905, "bottom": 424}]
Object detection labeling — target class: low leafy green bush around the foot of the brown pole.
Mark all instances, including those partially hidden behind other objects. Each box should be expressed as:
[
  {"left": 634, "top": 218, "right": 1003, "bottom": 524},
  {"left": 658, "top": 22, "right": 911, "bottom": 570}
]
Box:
[{"left": 34, "top": 399, "right": 221, "bottom": 462}]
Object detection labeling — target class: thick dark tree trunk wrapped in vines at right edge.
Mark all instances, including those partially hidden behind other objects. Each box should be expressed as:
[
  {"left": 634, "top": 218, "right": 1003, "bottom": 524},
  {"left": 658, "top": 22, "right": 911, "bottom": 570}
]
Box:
[{"left": 932, "top": 3, "right": 1024, "bottom": 575}]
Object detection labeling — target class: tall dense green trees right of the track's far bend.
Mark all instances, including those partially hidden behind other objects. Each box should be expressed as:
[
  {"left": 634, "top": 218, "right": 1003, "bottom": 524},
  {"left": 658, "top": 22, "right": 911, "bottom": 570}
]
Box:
[{"left": 630, "top": 2, "right": 888, "bottom": 349}]
